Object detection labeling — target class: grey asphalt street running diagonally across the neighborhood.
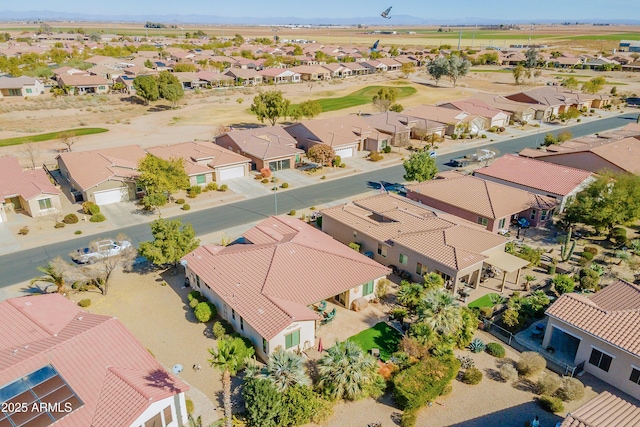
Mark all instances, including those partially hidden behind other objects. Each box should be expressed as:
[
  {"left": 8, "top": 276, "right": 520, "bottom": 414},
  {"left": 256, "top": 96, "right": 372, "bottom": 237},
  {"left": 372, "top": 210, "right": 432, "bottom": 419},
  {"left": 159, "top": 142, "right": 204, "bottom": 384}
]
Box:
[{"left": 0, "top": 113, "right": 638, "bottom": 287}]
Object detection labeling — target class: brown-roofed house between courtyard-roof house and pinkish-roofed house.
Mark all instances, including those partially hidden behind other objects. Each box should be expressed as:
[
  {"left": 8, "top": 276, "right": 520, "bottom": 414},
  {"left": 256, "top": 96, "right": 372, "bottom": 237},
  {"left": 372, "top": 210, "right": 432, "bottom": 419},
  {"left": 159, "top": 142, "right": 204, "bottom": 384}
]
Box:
[{"left": 406, "top": 172, "right": 558, "bottom": 233}]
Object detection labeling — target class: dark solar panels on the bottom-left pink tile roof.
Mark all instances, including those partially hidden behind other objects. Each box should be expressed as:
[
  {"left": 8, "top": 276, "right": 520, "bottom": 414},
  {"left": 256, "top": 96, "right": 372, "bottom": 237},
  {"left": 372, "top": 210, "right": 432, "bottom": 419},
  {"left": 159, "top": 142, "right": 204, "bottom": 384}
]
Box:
[{"left": 0, "top": 365, "right": 83, "bottom": 427}]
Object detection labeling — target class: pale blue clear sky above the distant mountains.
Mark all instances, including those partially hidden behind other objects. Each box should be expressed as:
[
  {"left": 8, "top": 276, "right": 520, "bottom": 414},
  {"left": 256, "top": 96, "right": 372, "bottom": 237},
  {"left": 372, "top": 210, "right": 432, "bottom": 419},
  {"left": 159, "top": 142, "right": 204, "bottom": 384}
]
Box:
[{"left": 5, "top": 0, "right": 640, "bottom": 22}]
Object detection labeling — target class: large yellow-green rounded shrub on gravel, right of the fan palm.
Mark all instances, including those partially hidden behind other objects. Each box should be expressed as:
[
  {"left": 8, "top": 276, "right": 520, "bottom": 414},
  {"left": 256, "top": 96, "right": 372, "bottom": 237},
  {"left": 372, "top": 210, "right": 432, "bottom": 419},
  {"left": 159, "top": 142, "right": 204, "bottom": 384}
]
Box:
[{"left": 393, "top": 357, "right": 460, "bottom": 410}]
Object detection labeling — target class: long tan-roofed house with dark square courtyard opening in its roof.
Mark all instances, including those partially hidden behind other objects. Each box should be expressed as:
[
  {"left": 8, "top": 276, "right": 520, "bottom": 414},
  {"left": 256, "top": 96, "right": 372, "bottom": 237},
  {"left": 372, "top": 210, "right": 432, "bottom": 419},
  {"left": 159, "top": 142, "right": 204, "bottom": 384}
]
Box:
[{"left": 322, "top": 193, "right": 526, "bottom": 293}]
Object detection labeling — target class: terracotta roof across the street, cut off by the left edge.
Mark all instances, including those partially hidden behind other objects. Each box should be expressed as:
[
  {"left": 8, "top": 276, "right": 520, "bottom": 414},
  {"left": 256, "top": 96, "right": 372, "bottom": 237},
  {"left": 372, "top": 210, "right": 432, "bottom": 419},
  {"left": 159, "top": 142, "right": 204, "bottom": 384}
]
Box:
[{"left": 0, "top": 156, "right": 60, "bottom": 202}]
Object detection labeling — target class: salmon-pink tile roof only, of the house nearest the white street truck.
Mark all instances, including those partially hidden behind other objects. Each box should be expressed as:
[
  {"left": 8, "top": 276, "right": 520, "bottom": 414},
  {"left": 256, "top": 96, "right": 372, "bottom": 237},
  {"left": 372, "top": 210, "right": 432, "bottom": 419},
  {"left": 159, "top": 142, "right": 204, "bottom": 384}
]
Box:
[{"left": 474, "top": 154, "right": 591, "bottom": 196}]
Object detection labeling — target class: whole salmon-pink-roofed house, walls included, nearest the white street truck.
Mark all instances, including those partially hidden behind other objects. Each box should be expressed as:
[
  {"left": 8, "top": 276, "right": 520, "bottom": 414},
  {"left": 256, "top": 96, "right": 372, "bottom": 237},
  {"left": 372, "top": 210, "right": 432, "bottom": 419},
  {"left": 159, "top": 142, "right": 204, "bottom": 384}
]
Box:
[{"left": 473, "top": 154, "right": 595, "bottom": 212}]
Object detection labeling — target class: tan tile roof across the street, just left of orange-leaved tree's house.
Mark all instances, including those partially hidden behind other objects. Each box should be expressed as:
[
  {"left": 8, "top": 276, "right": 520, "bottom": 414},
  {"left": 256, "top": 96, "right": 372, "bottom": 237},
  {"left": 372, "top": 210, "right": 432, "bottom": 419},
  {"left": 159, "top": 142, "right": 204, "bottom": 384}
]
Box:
[{"left": 216, "top": 126, "right": 304, "bottom": 160}]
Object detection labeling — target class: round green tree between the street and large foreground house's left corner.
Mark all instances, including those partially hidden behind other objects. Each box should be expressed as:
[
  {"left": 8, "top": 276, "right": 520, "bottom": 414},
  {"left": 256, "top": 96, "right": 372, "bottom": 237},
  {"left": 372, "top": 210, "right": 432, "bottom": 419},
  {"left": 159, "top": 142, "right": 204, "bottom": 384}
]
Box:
[{"left": 139, "top": 218, "right": 200, "bottom": 265}]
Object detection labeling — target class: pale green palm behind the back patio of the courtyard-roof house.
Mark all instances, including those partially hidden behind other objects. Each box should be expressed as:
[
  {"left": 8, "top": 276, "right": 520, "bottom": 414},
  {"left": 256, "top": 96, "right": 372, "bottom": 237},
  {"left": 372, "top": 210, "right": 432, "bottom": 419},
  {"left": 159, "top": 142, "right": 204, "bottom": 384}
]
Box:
[{"left": 418, "top": 289, "right": 462, "bottom": 335}]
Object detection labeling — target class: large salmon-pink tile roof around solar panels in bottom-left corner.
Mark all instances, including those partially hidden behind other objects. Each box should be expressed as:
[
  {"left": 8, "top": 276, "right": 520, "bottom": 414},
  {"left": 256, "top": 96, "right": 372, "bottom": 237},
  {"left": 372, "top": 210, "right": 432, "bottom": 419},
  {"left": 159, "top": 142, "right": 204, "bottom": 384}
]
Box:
[{"left": 0, "top": 294, "right": 189, "bottom": 427}]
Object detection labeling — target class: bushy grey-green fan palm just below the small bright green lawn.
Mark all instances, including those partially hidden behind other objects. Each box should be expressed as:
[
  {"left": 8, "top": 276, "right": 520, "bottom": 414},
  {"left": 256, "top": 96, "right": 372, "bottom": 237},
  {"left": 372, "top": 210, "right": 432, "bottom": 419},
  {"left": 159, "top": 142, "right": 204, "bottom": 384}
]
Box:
[{"left": 318, "top": 341, "right": 378, "bottom": 400}]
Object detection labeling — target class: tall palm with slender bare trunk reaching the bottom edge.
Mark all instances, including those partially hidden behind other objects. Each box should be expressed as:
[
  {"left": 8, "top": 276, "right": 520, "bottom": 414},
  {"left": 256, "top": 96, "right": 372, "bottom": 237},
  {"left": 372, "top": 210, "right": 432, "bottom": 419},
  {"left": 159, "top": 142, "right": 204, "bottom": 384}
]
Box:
[{"left": 209, "top": 337, "right": 253, "bottom": 427}]
